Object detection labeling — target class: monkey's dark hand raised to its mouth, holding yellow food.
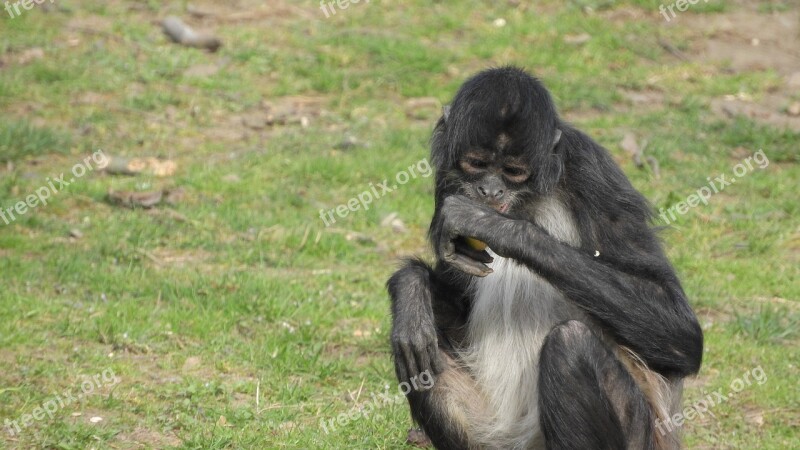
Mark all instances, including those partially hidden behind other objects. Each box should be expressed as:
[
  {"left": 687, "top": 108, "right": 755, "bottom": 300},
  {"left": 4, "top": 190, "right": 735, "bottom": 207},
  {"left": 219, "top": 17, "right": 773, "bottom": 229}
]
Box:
[{"left": 438, "top": 195, "right": 506, "bottom": 277}]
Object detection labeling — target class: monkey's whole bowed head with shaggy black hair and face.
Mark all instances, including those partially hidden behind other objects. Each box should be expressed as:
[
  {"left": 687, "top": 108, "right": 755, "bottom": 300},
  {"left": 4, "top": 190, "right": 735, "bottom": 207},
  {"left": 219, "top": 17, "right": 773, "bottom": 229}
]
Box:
[{"left": 432, "top": 67, "right": 563, "bottom": 213}]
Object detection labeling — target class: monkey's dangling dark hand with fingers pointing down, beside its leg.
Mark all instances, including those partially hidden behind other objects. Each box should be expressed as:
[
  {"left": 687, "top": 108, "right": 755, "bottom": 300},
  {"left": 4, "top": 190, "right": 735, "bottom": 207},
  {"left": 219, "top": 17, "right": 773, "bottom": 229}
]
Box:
[{"left": 391, "top": 302, "right": 445, "bottom": 381}]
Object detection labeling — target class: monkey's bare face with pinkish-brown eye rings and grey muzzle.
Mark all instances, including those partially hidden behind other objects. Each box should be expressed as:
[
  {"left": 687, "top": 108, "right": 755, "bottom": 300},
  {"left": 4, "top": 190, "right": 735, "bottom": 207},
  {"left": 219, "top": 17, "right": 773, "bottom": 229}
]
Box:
[{"left": 458, "top": 144, "right": 532, "bottom": 214}]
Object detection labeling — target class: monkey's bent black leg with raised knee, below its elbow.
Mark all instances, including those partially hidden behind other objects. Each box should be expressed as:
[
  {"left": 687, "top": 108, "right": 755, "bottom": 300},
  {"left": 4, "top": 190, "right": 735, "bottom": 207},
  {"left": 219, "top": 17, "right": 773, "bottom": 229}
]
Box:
[{"left": 539, "top": 320, "right": 655, "bottom": 450}]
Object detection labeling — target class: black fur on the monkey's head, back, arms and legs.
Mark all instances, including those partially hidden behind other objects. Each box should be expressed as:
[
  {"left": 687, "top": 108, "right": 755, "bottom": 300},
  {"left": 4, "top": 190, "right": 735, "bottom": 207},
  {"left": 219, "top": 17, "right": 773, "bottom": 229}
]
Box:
[{"left": 388, "top": 67, "right": 703, "bottom": 448}]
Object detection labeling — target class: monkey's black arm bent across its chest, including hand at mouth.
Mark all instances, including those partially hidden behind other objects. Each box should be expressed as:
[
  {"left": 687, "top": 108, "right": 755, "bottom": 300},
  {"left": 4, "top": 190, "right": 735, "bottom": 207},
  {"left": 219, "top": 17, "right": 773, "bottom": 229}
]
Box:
[{"left": 443, "top": 196, "right": 703, "bottom": 376}]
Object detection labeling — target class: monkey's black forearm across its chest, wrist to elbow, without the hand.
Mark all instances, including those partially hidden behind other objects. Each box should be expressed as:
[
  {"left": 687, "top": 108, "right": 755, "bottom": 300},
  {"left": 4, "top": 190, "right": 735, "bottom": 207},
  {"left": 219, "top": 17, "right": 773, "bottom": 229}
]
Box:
[{"left": 503, "top": 221, "right": 703, "bottom": 376}]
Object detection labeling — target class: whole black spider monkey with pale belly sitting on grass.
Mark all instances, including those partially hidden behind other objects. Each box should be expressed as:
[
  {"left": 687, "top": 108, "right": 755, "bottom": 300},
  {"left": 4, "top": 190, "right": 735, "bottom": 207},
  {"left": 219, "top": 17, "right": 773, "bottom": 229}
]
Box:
[{"left": 387, "top": 67, "right": 703, "bottom": 450}]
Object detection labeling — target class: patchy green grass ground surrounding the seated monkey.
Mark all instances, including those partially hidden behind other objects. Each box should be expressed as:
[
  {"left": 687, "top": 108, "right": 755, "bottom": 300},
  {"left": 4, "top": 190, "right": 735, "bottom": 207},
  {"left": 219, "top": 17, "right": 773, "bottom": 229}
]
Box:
[{"left": 0, "top": 0, "right": 800, "bottom": 449}]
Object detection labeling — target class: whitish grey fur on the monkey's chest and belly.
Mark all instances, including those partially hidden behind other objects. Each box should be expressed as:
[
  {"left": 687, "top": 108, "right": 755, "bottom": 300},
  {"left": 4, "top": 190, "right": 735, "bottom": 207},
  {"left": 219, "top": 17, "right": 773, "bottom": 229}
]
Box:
[{"left": 465, "top": 198, "right": 582, "bottom": 448}]
